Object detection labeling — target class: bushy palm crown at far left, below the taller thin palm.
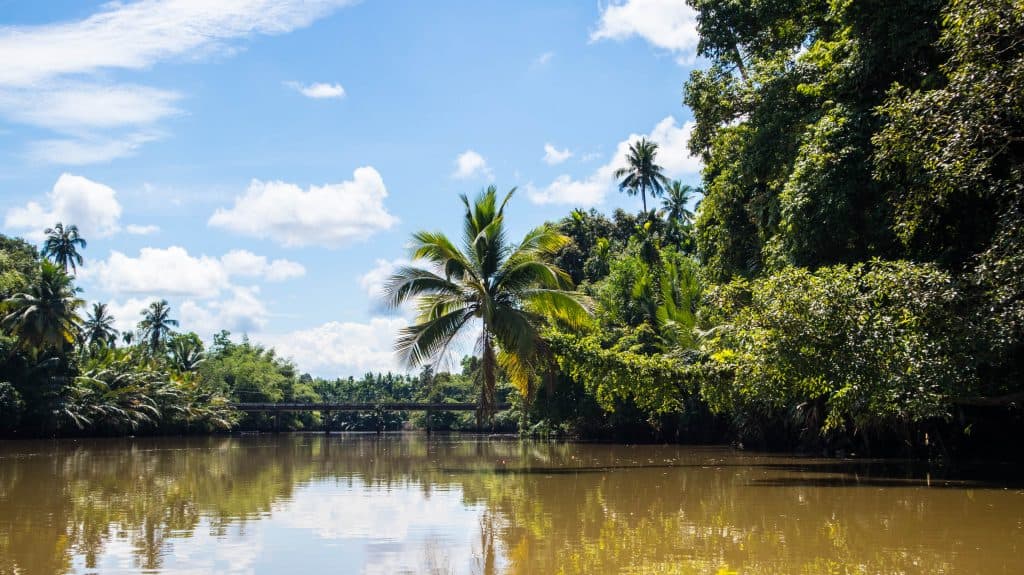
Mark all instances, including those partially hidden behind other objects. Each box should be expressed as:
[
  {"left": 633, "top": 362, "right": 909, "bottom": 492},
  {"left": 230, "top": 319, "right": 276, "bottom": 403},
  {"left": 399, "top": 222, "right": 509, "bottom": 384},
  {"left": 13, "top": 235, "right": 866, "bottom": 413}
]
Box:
[{"left": 2, "top": 261, "right": 84, "bottom": 352}]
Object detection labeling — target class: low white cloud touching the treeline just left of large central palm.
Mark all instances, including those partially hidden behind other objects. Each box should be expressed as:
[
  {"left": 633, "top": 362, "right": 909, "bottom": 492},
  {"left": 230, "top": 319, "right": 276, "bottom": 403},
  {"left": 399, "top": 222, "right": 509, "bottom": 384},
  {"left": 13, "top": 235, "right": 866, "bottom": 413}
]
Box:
[{"left": 258, "top": 317, "right": 409, "bottom": 377}]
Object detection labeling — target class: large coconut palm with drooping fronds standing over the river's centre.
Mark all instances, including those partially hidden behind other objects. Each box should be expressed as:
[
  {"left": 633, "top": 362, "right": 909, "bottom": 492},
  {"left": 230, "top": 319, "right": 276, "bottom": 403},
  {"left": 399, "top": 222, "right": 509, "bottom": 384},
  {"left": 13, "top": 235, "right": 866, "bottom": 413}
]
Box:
[{"left": 385, "top": 186, "right": 590, "bottom": 419}]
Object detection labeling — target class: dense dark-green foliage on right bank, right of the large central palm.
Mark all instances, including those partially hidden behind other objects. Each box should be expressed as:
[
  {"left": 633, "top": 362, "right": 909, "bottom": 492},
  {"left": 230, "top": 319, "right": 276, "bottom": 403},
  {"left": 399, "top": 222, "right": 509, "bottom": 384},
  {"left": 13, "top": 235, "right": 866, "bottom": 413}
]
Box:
[{"left": 538, "top": 0, "right": 1024, "bottom": 449}]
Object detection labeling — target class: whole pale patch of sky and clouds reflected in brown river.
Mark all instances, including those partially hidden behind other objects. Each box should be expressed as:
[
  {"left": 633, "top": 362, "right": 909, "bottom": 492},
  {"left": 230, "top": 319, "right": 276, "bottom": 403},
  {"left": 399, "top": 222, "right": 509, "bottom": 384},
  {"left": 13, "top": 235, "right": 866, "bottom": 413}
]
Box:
[{"left": 72, "top": 480, "right": 491, "bottom": 575}]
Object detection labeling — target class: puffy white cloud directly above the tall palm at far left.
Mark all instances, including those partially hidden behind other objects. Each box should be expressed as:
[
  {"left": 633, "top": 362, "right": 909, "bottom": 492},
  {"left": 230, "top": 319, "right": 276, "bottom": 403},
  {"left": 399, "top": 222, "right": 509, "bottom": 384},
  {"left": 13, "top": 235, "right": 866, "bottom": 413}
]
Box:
[{"left": 4, "top": 174, "right": 121, "bottom": 240}]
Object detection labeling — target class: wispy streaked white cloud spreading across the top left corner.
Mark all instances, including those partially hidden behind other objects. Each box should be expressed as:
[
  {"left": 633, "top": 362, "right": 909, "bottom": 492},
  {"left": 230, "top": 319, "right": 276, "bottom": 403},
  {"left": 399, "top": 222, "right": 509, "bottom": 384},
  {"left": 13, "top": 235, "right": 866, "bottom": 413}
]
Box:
[{"left": 0, "top": 0, "right": 350, "bottom": 165}]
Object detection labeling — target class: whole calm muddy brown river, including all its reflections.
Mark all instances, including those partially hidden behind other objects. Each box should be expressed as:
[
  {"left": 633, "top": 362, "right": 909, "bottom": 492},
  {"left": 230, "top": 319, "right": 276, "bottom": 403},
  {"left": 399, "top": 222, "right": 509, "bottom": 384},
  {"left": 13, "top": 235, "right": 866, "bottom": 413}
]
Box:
[{"left": 0, "top": 434, "right": 1024, "bottom": 575}]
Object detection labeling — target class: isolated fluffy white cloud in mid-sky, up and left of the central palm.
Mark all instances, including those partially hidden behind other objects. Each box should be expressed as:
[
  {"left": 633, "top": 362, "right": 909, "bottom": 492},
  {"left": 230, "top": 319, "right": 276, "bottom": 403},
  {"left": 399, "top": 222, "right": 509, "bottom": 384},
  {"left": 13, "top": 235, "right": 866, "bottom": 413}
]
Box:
[{"left": 208, "top": 167, "right": 397, "bottom": 247}]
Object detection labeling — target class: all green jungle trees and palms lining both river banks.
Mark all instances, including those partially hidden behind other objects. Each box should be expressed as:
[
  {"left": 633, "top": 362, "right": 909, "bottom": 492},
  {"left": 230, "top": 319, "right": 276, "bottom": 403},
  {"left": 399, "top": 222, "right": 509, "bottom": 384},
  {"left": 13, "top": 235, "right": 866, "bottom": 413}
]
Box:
[{"left": 0, "top": 0, "right": 1024, "bottom": 454}]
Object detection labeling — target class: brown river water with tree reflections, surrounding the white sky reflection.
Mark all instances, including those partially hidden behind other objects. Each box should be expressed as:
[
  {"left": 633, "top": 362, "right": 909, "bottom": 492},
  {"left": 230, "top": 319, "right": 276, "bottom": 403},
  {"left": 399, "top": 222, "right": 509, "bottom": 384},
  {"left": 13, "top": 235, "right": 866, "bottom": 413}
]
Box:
[{"left": 0, "top": 436, "right": 1024, "bottom": 575}]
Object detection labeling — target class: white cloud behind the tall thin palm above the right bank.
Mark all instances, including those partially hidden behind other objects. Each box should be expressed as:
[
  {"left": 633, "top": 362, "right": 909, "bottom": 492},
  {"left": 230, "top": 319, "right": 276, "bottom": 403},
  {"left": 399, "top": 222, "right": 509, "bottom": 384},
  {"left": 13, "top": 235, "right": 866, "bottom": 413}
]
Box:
[{"left": 525, "top": 116, "right": 700, "bottom": 207}]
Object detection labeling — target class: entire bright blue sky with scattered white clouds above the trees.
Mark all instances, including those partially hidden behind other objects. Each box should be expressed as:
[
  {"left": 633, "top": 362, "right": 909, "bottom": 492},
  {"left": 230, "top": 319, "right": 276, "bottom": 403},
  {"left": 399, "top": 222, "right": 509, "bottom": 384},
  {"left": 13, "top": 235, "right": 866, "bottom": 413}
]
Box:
[{"left": 0, "top": 0, "right": 699, "bottom": 375}]
